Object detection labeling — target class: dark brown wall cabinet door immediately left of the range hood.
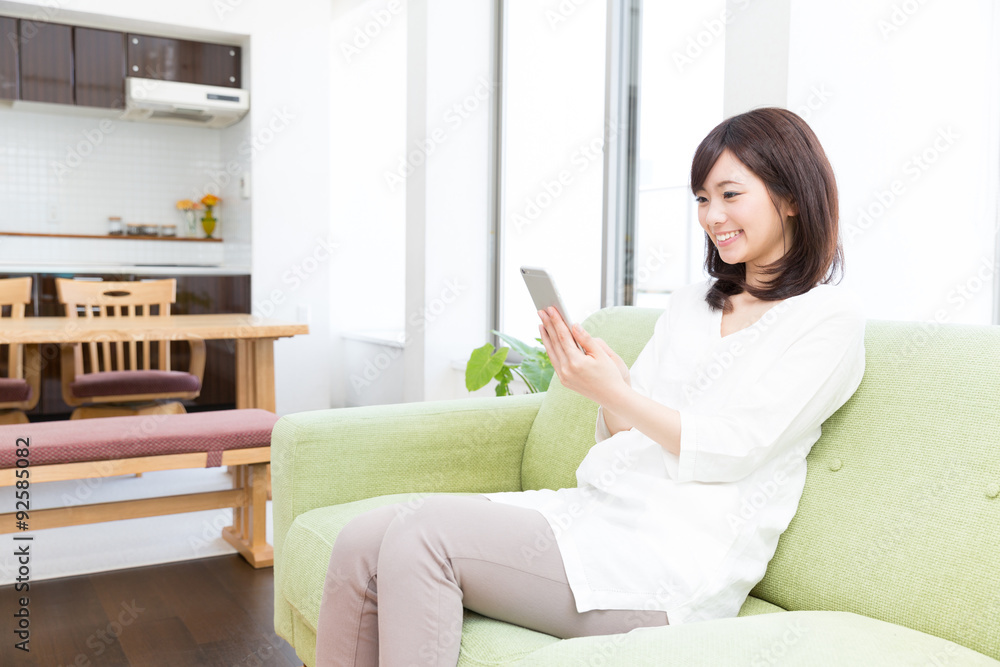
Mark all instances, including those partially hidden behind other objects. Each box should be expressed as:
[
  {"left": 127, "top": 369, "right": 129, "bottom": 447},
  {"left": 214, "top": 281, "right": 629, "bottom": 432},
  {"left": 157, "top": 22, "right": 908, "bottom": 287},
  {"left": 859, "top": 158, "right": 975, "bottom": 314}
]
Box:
[{"left": 73, "top": 27, "right": 125, "bottom": 109}]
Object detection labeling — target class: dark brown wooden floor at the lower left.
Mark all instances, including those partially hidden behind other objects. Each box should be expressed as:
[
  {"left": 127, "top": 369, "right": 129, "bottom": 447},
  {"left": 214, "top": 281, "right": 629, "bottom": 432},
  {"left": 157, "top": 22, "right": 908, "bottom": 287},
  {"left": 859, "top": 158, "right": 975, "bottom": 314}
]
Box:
[{"left": 0, "top": 555, "right": 302, "bottom": 667}]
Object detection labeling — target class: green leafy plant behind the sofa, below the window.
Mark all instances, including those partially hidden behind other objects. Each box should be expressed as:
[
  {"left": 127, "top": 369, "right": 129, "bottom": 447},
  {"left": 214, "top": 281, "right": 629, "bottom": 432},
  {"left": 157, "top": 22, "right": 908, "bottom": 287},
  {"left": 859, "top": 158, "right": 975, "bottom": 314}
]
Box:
[{"left": 465, "top": 330, "right": 552, "bottom": 396}]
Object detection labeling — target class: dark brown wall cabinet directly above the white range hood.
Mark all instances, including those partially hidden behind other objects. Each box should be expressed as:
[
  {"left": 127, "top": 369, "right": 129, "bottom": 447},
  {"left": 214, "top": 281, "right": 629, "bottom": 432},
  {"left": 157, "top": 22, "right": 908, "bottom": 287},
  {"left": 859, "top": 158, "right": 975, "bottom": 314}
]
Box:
[{"left": 126, "top": 33, "right": 240, "bottom": 88}]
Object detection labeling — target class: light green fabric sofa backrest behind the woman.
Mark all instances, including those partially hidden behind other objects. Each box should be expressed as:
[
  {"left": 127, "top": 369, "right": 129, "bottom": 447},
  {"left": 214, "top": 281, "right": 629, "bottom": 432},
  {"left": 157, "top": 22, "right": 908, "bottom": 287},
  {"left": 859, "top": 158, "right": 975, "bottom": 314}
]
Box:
[{"left": 522, "top": 307, "right": 1000, "bottom": 659}]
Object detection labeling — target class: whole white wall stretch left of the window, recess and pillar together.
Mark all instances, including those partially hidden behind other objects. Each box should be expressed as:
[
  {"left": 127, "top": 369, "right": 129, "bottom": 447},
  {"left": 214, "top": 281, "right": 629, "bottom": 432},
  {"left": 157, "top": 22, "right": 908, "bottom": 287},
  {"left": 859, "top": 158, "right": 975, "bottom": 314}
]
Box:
[{"left": 332, "top": 0, "right": 495, "bottom": 405}]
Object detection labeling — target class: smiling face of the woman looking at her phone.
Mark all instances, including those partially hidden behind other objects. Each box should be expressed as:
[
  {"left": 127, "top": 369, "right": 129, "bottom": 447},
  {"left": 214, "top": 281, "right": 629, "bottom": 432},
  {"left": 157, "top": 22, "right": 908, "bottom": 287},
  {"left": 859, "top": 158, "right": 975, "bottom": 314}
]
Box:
[{"left": 695, "top": 150, "right": 798, "bottom": 286}]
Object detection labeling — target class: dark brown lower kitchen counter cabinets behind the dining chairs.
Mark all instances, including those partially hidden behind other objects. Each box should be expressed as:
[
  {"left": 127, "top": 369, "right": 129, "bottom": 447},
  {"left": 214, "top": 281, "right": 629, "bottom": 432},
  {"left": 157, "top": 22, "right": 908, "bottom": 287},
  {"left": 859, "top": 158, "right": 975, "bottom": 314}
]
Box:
[{"left": 0, "top": 273, "right": 250, "bottom": 421}]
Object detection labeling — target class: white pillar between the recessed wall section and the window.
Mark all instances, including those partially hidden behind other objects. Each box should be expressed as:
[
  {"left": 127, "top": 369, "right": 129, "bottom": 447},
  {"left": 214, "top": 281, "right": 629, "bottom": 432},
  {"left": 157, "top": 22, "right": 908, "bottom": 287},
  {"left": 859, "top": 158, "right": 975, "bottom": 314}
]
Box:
[{"left": 414, "top": 0, "right": 496, "bottom": 400}]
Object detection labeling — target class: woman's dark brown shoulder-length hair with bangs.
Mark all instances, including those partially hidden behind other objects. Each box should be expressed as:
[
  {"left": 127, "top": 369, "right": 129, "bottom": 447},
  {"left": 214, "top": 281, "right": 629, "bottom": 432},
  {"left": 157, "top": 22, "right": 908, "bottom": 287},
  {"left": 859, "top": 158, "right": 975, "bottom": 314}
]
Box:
[{"left": 691, "top": 107, "right": 844, "bottom": 313}]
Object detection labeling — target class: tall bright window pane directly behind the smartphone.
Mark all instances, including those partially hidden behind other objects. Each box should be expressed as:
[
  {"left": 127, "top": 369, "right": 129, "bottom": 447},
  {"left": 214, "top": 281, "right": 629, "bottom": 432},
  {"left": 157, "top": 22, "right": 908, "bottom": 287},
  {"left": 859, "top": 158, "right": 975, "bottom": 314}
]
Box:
[{"left": 497, "top": 0, "right": 607, "bottom": 342}]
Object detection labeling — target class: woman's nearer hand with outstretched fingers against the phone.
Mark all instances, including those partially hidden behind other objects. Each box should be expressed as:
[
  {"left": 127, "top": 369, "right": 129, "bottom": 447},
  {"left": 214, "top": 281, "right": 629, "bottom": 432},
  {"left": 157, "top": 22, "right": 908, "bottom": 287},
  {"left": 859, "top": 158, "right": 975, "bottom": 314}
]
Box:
[{"left": 538, "top": 307, "right": 629, "bottom": 404}]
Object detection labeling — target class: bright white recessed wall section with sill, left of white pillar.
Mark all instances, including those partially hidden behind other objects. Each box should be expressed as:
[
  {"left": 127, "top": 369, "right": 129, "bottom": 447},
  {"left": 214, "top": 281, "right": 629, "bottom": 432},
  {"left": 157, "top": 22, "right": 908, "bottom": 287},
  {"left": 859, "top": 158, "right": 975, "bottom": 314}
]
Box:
[{"left": 329, "top": 0, "right": 406, "bottom": 406}]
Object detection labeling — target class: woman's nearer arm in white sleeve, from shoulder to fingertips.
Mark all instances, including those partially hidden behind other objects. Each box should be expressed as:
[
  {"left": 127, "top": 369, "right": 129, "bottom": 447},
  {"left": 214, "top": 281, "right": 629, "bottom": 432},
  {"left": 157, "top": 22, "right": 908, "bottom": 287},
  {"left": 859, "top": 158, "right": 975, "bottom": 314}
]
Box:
[{"left": 542, "top": 298, "right": 866, "bottom": 482}]
